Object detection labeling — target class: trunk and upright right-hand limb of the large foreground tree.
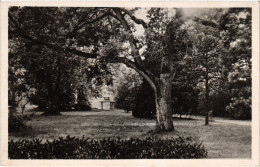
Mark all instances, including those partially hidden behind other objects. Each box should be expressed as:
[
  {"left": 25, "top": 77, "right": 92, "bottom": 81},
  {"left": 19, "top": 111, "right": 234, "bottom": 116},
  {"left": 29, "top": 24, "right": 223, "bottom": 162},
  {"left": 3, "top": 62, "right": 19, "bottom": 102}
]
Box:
[{"left": 152, "top": 19, "right": 176, "bottom": 131}]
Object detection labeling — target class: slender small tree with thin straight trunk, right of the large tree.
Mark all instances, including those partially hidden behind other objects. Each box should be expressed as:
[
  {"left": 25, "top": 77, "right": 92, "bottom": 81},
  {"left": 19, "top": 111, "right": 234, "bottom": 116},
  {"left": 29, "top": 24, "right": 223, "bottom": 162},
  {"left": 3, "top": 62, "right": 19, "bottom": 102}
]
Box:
[{"left": 188, "top": 34, "right": 220, "bottom": 125}]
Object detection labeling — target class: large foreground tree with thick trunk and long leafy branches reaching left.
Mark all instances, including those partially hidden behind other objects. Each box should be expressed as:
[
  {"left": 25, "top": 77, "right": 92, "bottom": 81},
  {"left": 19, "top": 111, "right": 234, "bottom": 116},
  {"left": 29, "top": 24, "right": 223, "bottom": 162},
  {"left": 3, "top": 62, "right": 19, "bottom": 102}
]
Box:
[{"left": 9, "top": 8, "right": 187, "bottom": 131}]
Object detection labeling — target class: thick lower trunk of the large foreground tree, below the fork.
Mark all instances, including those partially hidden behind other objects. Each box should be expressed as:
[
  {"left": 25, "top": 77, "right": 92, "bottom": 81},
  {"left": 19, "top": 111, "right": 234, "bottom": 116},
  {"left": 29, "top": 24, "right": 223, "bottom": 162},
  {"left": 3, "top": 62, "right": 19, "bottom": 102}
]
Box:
[{"left": 155, "top": 74, "right": 174, "bottom": 131}]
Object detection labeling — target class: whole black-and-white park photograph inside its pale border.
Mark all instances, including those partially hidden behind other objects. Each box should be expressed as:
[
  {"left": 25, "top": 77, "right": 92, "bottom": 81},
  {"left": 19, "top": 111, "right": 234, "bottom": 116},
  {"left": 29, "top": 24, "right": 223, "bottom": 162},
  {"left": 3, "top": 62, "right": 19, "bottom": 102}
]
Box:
[{"left": 1, "top": 2, "right": 259, "bottom": 166}]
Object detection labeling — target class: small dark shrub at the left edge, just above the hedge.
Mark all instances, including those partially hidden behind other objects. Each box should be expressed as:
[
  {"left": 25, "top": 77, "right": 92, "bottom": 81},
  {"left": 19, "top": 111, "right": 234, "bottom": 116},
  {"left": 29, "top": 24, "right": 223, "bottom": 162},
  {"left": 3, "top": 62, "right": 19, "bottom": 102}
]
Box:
[{"left": 8, "top": 113, "right": 30, "bottom": 132}]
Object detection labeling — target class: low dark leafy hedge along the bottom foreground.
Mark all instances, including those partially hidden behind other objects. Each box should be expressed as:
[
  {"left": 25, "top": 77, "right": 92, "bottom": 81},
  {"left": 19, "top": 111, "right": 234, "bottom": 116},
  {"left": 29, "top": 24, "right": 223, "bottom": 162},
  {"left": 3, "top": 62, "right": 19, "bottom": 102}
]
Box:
[{"left": 8, "top": 136, "right": 207, "bottom": 159}]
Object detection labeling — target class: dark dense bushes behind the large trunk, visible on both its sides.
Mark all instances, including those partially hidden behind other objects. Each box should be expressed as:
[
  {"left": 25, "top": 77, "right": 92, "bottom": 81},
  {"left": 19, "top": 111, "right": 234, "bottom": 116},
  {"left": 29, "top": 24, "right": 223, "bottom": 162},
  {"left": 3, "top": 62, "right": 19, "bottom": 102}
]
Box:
[{"left": 115, "top": 79, "right": 199, "bottom": 118}]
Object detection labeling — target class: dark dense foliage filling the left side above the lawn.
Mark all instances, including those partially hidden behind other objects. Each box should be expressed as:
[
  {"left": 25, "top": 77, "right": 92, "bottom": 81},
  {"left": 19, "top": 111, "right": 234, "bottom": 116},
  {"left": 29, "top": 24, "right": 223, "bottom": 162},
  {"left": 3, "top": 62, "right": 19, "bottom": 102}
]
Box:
[{"left": 8, "top": 7, "right": 111, "bottom": 115}]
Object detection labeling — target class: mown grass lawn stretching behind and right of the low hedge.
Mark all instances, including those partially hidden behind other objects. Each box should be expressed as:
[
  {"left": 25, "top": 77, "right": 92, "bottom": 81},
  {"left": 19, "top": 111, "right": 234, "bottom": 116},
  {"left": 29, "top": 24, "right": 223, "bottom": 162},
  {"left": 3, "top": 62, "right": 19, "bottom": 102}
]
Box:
[{"left": 9, "top": 110, "right": 251, "bottom": 158}]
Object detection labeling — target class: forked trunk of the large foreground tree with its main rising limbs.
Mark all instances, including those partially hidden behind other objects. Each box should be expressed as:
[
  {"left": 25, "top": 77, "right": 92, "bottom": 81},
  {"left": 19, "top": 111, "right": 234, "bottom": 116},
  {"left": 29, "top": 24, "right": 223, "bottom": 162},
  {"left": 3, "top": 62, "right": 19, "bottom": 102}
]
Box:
[{"left": 113, "top": 9, "right": 177, "bottom": 131}]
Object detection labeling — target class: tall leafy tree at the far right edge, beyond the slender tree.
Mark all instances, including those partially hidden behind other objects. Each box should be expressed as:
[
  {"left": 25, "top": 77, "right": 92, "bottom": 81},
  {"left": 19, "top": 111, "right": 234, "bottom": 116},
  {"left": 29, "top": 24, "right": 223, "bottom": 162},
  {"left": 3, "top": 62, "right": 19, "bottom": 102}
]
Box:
[{"left": 220, "top": 8, "right": 252, "bottom": 119}]
